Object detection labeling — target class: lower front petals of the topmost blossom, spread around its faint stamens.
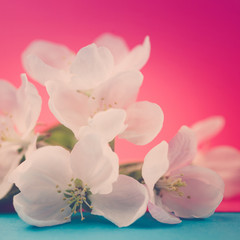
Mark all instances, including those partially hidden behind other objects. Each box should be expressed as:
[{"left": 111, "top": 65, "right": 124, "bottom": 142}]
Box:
[{"left": 47, "top": 71, "right": 163, "bottom": 145}]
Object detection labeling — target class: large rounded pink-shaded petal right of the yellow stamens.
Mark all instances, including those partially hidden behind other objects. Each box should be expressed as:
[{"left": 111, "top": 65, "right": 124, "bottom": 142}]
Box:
[{"left": 161, "top": 166, "right": 224, "bottom": 218}]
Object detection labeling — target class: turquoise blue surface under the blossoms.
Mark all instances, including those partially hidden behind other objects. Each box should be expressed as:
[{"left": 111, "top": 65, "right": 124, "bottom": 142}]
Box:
[{"left": 0, "top": 213, "right": 240, "bottom": 240}]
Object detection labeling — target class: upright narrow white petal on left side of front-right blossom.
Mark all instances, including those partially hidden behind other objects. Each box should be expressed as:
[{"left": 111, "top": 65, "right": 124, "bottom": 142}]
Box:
[{"left": 142, "top": 141, "right": 169, "bottom": 194}]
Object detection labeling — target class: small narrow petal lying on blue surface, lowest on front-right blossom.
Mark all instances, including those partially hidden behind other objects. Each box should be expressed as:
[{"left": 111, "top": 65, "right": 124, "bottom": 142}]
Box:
[{"left": 148, "top": 201, "right": 182, "bottom": 224}]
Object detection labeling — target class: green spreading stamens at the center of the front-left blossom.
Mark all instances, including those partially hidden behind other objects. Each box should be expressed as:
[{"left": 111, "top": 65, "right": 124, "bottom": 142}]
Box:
[{"left": 56, "top": 178, "right": 92, "bottom": 220}]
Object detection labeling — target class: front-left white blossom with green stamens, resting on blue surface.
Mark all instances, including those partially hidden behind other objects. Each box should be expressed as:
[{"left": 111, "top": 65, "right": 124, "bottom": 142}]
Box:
[{"left": 11, "top": 128, "right": 148, "bottom": 227}]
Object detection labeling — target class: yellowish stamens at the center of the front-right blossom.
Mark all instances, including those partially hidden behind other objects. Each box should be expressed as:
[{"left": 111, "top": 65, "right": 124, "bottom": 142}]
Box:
[{"left": 154, "top": 175, "right": 186, "bottom": 197}]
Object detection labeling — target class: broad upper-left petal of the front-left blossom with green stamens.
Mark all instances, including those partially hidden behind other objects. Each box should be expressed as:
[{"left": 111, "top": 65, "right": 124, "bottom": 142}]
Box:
[{"left": 10, "top": 146, "right": 73, "bottom": 204}]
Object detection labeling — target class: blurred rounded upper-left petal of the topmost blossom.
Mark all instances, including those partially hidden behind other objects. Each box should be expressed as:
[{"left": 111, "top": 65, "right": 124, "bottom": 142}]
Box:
[{"left": 22, "top": 40, "right": 75, "bottom": 84}]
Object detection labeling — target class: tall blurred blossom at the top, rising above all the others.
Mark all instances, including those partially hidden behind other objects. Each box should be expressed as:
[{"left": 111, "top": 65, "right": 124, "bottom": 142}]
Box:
[{"left": 23, "top": 34, "right": 160, "bottom": 145}]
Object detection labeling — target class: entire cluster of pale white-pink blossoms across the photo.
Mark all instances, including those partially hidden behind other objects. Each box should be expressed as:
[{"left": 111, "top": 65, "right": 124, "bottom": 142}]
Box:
[{"left": 0, "top": 34, "right": 236, "bottom": 227}]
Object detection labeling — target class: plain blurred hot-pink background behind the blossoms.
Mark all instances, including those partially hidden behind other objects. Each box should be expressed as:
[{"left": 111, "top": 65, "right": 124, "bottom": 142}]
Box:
[{"left": 0, "top": 0, "right": 240, "bottom": 209}]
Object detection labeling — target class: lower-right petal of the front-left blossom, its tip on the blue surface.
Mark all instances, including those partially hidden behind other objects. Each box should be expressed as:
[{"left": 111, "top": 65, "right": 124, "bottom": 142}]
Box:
[{"left": 90, "top": 175, "right": 148, "bottom": 227}]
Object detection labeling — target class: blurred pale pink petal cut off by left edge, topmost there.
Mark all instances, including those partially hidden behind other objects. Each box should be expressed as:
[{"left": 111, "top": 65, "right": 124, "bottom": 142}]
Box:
[{"left": 0, "top": 80, "right": 17, "bottom": 114}]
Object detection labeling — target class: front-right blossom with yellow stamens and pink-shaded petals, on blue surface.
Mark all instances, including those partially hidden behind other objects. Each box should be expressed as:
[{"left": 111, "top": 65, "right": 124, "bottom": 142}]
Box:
[{"left": 142, "top": 126, "right": 224, "bottom": 224}]
